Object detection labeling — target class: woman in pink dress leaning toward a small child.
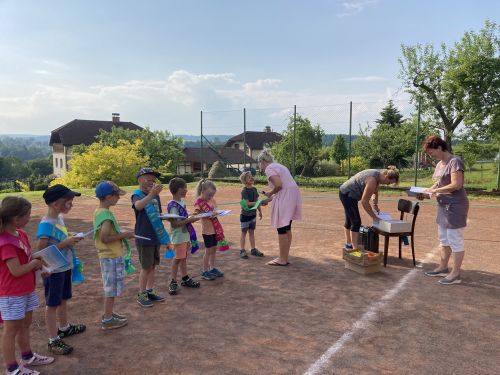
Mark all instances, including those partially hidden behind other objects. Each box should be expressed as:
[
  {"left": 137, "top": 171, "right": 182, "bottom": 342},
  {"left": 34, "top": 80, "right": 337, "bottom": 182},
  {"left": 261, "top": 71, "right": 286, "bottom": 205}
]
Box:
[{"left": 257, "top": 150, "right": 302, "bottom": 266}]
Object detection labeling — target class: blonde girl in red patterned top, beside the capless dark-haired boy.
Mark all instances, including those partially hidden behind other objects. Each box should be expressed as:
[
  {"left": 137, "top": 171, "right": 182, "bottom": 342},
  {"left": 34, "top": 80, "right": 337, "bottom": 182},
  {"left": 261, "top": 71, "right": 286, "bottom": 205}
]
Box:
[{"left": 194, "top": 178, "right": 229, "bottom": 280}]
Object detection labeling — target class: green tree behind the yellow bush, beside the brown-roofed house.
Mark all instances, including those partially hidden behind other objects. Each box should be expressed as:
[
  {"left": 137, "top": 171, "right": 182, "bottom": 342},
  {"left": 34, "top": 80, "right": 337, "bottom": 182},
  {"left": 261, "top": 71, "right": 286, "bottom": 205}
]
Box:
[{"left": 94, "top": 127, "right": 184, "bottom": 173}]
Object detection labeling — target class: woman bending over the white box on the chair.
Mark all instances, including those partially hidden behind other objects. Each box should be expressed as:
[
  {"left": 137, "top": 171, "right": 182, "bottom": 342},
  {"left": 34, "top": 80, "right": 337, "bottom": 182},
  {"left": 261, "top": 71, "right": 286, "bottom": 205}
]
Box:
[{"left": 339, "top": 165, "right": 399, "bottom": 250}]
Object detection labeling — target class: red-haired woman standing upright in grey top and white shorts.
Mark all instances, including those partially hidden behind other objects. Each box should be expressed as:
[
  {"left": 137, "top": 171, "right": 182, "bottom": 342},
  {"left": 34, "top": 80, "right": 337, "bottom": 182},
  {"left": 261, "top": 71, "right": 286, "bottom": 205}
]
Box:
[{"left": 418, "top": 135, "right": 469, "bottom": 285}]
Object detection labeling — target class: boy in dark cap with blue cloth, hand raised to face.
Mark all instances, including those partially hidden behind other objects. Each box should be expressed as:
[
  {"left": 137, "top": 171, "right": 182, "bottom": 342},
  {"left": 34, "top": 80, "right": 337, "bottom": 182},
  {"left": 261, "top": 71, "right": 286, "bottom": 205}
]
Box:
[{"left": 132, "top": 167, "right": 168, "bottom": 307}]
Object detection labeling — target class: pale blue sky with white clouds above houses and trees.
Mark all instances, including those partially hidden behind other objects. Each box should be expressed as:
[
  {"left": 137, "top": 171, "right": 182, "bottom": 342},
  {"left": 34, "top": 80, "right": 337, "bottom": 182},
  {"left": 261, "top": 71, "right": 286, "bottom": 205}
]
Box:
[{"left": 0, "top": 0, "right": 500, "bottom": 134}]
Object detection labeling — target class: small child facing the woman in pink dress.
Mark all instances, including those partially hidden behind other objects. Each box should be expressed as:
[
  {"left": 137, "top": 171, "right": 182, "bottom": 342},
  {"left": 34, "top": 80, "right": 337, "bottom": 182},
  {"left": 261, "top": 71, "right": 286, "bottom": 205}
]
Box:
[{"left": 240, "top": 172, "right": 264, "bottom": 259}]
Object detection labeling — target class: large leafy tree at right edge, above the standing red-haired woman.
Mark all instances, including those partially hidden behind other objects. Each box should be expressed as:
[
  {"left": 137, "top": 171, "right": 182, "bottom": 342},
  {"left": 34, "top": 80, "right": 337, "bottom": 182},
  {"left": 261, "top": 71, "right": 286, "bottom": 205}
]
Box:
[{"left": 399, "top": 21, "right": 500, "bottom": 150}]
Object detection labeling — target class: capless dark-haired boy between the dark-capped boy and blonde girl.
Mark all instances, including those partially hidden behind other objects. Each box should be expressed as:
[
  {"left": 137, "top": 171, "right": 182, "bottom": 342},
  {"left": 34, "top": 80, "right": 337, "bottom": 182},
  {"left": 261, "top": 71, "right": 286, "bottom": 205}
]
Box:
[{"left": 168, "top": 177, "right": 200, "bottom": 295}]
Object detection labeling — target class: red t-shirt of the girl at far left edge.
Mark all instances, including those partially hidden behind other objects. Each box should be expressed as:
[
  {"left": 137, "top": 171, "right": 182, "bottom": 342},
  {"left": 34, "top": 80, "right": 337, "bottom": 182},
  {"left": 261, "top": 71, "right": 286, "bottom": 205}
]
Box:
[{"left": 0, "top": 229, "right": 35, "bottom": 296}]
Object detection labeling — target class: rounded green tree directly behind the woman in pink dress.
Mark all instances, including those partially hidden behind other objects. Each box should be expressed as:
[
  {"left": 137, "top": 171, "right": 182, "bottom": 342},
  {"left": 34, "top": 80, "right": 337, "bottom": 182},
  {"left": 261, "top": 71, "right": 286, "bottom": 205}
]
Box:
[{"left": 272, "top": 115, "right": 325, "bottom": 176}]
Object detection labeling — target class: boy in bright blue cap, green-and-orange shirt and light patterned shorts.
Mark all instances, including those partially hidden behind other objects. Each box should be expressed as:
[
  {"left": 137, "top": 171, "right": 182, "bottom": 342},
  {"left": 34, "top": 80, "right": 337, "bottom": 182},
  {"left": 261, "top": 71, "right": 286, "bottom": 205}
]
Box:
[{"left": 94, "top": 181, "right": 134, "bottom": 330}]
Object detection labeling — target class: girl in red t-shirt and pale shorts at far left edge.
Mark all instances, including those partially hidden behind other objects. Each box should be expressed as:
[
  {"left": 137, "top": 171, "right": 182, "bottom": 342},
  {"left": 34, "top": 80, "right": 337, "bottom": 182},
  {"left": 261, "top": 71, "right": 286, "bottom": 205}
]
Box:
[{"left": 0, "top": 197, "right": 54, "bottom": 375}]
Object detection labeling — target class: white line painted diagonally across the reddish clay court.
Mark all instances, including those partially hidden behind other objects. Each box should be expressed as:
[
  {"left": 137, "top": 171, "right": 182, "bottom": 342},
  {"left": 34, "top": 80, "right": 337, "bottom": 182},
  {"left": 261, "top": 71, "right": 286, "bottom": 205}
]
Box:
[{"left": 304, "top": 247, "right": 439, "bottom": 375}]
